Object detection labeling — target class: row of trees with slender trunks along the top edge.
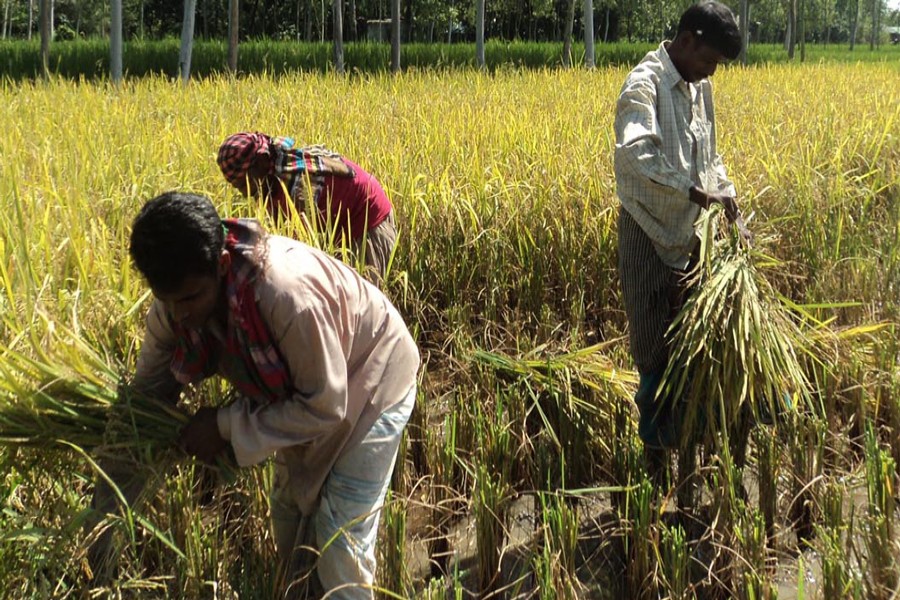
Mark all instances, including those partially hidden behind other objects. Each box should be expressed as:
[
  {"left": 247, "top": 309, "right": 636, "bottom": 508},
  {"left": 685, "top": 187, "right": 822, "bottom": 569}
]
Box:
[{"left": 0, "top": 0, "right": 900, "bottom": 77}]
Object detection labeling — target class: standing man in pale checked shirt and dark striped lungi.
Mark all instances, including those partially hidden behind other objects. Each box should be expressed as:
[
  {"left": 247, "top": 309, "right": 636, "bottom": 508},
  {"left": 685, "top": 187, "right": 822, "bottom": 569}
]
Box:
[{"left": 615, "top": 2, "right": 750, "bottom": 477}]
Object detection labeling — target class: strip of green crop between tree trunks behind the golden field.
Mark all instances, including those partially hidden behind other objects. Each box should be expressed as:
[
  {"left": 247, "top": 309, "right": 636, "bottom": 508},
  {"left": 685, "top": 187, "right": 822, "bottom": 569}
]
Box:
[{"left": 0, "top": 38, "right": 900, "bottom": 79}]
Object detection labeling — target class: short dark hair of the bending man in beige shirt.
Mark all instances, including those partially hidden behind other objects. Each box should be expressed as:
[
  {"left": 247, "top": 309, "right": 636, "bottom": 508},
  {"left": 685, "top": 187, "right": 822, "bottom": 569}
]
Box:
[{"left": 128, "top": 192, "right": 225, "bottom": 293}]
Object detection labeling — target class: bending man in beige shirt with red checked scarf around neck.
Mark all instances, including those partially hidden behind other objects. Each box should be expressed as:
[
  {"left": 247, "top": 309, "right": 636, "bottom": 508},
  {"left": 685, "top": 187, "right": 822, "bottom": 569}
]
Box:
[{"left": 100, "top": 193, "right": 419, "bottom": 598}]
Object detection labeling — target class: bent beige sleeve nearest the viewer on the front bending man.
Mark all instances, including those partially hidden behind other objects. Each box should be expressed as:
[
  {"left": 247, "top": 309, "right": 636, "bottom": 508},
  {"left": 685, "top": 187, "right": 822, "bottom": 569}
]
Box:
[{"left": 217, "top": 293, "right": 352, "bottom": 466}]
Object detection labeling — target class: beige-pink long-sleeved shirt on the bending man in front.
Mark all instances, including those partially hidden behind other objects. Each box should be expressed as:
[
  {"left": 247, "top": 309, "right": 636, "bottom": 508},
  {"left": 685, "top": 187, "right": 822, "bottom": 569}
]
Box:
[{"left": 133, "top": 236, "right": 419, "bottom": 512}]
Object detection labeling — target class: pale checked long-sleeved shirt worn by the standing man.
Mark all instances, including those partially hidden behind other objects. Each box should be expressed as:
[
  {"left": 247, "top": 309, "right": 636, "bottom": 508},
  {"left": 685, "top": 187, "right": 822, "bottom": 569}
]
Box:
[{"left": 615, "top": 42, "right": 735, "bottom": 269}]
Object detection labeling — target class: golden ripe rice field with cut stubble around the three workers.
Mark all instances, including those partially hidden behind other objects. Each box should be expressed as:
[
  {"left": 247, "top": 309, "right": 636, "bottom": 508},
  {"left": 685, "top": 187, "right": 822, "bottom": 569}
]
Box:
[{"left": 0, "top": 63, "right": 900, "bottom": 598}]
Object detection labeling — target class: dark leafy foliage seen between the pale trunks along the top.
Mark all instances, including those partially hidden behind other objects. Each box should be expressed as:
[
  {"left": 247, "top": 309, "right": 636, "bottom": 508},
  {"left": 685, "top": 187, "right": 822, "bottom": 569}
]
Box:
[{"left": 3, "top": 0, "right": 900, "bottom": 44}]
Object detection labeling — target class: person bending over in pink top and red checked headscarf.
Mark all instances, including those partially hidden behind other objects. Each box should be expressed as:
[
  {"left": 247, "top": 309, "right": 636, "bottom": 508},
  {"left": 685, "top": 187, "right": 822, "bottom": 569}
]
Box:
[{"left": 217, "top": 132, "right": 397, "bottom": 280}]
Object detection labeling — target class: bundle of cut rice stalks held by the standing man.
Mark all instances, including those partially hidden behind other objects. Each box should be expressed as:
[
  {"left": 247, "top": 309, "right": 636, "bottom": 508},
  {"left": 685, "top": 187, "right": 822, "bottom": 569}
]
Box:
[{"left": 658, "top": 207, "right": 816, "bottom": 439}]
